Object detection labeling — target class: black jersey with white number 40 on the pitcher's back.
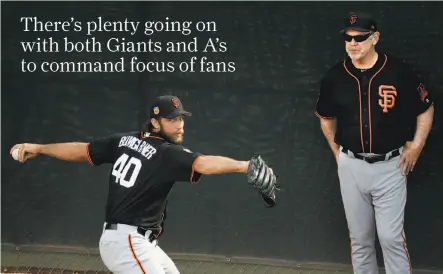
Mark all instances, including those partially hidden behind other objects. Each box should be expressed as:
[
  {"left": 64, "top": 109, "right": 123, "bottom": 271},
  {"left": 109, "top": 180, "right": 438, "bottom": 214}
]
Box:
[{"left": 88, "top": 132, "right": 202, "bottom": 234}]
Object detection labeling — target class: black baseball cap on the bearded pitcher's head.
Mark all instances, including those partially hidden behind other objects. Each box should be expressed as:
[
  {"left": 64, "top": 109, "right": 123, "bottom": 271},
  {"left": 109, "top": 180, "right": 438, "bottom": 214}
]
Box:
[{"left": 149, "top": 95, "right": 192, "bottom": 119}]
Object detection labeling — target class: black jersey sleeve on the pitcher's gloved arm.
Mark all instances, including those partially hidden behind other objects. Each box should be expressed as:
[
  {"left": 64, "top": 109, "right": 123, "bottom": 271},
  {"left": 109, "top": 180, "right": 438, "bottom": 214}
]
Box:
[{"left": 165, "top": 145, "right": 202, "bottom": 184}]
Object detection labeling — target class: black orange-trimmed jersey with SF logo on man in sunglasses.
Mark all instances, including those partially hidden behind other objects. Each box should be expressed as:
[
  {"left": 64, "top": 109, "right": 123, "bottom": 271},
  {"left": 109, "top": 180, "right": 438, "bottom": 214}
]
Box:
[{"left": 316, "top": 53, "right": 433, "bottom": 154}]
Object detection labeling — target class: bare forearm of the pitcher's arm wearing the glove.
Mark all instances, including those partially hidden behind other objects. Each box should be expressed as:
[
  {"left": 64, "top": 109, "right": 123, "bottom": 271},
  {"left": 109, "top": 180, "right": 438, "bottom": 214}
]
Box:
[{"left": 194, "top": 156, "right": 249, "bottom": 174}]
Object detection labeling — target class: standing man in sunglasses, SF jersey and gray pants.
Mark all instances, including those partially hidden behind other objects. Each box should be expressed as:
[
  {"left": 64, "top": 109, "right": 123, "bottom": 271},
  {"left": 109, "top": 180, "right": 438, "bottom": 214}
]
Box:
[{"left": 316, "top": 13, "right": 434, "bottom": 274}]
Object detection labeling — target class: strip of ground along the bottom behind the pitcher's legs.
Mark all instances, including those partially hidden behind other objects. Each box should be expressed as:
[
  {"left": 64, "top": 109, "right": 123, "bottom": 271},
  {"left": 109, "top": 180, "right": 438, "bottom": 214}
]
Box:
[{"left": 1, "top": 250, "right": 352, "bottom": 274}]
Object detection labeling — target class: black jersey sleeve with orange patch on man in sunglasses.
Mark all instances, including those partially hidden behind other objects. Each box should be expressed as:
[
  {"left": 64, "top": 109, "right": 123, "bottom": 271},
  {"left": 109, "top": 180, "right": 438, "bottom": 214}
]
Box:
[{"left": 401, "top": 64, "right": 433, "bottom": 115}]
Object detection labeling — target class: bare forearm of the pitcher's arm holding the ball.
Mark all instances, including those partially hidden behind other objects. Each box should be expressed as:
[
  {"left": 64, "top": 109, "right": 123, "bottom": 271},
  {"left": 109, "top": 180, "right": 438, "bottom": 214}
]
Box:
[{"left": 39, "top": 142, "right": 88, "bottom": 162}]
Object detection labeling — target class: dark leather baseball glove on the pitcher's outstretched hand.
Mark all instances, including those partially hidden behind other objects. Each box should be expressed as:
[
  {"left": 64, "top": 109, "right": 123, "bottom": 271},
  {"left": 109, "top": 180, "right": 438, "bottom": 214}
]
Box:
[{"left": 247, "top": 155, "right": 277, "bottom": 207}]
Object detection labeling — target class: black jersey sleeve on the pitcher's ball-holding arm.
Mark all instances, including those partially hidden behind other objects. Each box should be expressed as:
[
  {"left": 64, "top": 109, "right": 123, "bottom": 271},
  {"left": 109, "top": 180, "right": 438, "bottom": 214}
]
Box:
[{"left": 87, "top": 135, "right": 119, "bottom": 166}]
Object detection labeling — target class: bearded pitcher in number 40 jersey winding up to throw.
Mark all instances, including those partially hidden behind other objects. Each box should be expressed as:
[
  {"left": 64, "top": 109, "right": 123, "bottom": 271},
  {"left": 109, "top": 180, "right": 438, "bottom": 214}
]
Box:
[{"left": 11, "top": 95, "right": 276, "bottom": 274}]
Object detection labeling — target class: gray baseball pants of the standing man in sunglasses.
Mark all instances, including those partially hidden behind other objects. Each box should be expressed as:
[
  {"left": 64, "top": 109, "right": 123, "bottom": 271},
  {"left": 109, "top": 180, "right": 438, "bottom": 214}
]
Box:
[{"left": 338, "top": 148, "right": 412, "bottom": 274}]
